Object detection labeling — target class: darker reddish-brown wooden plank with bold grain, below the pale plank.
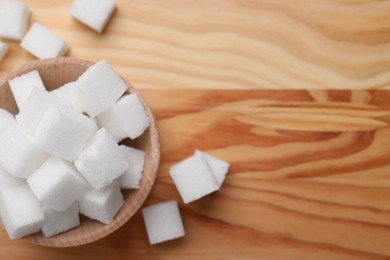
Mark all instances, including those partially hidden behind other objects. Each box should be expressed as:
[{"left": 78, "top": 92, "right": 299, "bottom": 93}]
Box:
[{"left": 0, "top": 90, "right": 390, "bottom": 259}]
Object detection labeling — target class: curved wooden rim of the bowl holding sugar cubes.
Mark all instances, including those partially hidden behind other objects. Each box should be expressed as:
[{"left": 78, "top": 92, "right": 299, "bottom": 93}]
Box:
[{"left": 0, "top": 57, "right": 161, "bottom": 247}]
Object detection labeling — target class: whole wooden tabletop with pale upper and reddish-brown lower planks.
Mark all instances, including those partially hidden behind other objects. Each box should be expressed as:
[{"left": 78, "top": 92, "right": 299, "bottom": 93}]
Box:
[{"left": 0, "top": 0, "right": 390, "bottom": 259}]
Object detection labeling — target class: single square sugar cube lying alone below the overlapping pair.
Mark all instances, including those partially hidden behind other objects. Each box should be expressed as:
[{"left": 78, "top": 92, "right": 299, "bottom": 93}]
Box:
[{"left": 142, "top": 200, "right": 185, "bottom": 245}]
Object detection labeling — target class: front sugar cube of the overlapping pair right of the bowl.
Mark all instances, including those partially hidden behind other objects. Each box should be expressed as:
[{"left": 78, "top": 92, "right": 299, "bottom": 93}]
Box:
[{"left": 169, "top": 154, "right": 219, "bottom": 203}]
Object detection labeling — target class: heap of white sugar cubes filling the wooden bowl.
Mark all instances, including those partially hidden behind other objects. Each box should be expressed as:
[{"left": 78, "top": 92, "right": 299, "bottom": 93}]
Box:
[{"left": 0, "top": 60, "right": 150, "bottom": 239}]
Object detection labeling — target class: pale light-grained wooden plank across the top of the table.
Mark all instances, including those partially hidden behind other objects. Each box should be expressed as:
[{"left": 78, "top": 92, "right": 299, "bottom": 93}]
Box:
[{"left": 0, "top": 0, "right": 390, "bottom": 89}]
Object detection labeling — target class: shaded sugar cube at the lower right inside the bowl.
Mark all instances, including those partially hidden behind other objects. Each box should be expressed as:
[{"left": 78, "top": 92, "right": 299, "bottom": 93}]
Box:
[{"left": 79, "top": 182, "right": 123, "bottom": 224}]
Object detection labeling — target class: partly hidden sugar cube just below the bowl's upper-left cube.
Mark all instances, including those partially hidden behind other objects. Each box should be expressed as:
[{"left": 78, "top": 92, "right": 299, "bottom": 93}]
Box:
[{"left": 16, "top": 88, "right": 67, "bottom": 136}]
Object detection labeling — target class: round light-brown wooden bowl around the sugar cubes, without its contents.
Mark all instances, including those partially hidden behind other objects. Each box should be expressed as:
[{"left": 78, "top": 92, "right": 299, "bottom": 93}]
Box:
[{"left": 0, "top": 57, "right": 160, "bottom": 247}]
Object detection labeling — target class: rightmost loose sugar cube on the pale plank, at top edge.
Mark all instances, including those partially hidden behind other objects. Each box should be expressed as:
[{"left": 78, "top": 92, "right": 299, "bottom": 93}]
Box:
[{"left": 70, "top": 0, "right": 116, "bottom": 33}]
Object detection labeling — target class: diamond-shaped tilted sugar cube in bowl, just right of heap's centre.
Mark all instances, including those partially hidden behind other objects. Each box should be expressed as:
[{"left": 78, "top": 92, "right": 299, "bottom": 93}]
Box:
[{"left": 75, "top": 128, "right": 129, "bottom": 189}]
